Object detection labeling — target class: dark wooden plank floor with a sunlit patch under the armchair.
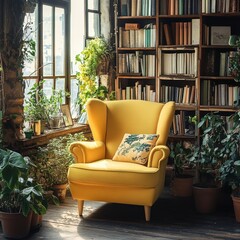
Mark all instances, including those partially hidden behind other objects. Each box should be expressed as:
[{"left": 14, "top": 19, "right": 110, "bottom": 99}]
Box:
[{"left": 0, "top": 189, "right": 240, "bottom": 240}]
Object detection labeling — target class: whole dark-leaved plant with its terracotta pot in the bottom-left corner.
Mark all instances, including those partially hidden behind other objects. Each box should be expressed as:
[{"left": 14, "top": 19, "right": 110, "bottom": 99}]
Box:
[{"left": 0, "top": 149, "right": 48, "bottom": 239}]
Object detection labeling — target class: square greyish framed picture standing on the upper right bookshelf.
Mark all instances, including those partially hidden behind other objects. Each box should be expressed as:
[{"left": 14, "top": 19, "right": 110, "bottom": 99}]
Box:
[{"left": 211, "top": 26, "right": 231, "bottom": 45}]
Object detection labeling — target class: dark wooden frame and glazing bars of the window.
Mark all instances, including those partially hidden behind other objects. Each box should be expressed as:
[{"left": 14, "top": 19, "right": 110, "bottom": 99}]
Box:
[{"left": 23, "top": 0, "right": 101, "bottom": 112}]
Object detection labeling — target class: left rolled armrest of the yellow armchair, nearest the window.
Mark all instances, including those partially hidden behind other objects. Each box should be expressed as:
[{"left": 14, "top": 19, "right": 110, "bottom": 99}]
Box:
[{"left": 69, "top": 141, "right": 105, "bottom": 163}]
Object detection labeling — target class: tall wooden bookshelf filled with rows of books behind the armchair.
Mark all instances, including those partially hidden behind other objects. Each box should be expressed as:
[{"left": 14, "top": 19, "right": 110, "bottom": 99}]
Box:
[{"left": 115, "top": 0, "right": 240, "bottom": 156}]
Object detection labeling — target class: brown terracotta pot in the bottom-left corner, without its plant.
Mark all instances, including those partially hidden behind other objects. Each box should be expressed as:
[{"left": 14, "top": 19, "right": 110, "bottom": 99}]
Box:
[{"left": 0, "top": 212, "right": 32, "bottom": 239}]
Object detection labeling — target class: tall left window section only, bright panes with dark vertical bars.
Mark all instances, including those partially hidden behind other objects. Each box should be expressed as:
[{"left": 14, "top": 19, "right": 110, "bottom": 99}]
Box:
[{"left": 23, "top": 1, "right": 69, "bottom": 104}]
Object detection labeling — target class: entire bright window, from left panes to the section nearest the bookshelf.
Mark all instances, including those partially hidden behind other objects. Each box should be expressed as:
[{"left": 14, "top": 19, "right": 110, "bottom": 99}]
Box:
[{"left": 23, "top": 0, "right": 100, "bottom": 117}]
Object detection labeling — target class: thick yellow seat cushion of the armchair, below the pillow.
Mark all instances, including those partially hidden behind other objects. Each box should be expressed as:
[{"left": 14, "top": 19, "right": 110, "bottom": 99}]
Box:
[{"left": 68, "top": 159, "right": 159, "bottom": 188}]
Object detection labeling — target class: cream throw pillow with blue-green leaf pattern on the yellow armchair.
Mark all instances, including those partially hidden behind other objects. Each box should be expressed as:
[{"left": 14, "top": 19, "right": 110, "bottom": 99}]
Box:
[{"left": 113, "top": 133, "right": 158, "bottom": 165}]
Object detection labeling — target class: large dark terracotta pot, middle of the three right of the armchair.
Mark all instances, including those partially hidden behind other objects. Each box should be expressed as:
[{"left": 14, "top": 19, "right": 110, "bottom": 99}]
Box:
[{"left": 193, "top": 185, "right": 220, "bottom": 214}]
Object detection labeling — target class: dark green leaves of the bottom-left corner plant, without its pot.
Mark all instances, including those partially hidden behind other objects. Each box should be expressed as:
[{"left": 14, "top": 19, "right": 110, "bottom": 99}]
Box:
[{"left": 0, "top": 149, "right": 48, "bottom": 216}]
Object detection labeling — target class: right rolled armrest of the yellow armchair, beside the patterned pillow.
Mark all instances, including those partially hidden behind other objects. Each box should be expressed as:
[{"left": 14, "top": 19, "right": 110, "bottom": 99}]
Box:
[{"left": 148, "top": 145, "right": 170, "bottom": 168}]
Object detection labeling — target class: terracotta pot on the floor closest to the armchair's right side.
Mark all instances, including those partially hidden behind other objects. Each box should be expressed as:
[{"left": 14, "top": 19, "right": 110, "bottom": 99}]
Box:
[{"left": 172, "top": 175, "right": 193, "bottom": 197}]
